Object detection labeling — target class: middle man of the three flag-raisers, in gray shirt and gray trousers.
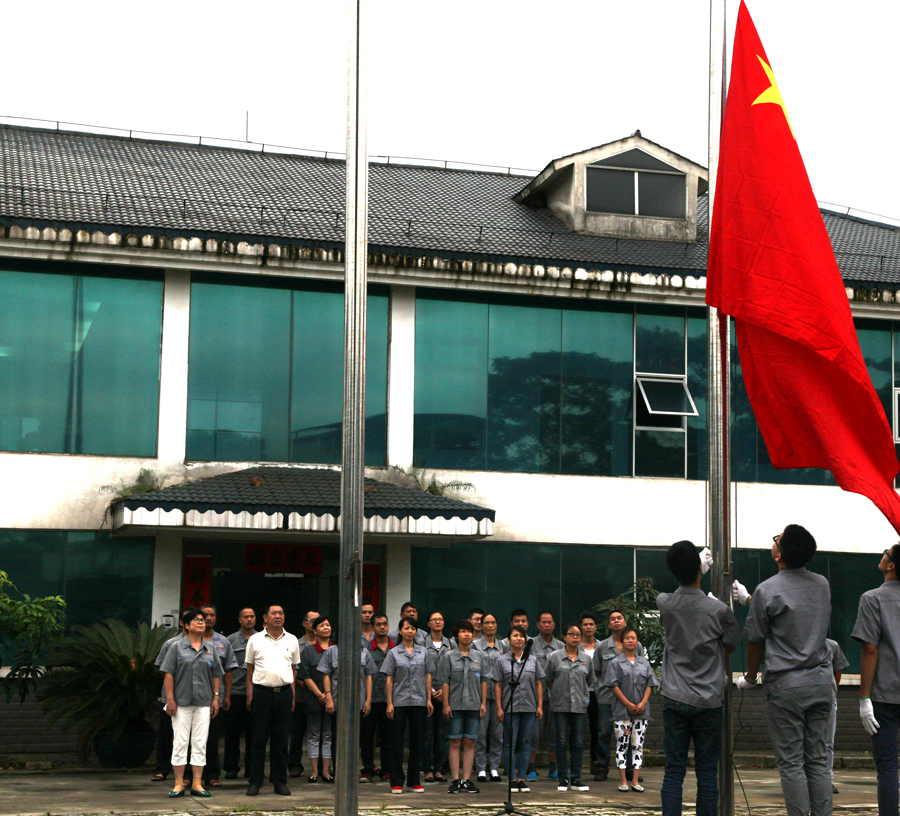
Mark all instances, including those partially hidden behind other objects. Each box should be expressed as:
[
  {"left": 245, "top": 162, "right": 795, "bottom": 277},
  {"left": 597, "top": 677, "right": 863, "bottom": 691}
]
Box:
[{"left": 737, "top": 524, "right": 835, "bottom": 816}]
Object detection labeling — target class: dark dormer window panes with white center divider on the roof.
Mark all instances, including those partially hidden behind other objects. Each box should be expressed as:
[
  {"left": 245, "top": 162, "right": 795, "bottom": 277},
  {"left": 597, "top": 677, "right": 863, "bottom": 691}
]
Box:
[{"left": 584, "top": 148, "right": 687, "bottom": 218}]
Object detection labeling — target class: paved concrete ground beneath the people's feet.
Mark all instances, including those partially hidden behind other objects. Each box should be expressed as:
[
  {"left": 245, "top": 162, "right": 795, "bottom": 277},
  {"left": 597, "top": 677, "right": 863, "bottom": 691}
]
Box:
[{"left": 0, "top": 768, "right": 877, "bottom": 816}]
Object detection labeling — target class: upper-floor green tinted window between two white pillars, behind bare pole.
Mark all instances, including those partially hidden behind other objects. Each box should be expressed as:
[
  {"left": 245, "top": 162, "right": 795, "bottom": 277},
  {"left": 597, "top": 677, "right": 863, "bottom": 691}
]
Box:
[{"left": 187, "top": 283, "right": 388, "bottom": 465}]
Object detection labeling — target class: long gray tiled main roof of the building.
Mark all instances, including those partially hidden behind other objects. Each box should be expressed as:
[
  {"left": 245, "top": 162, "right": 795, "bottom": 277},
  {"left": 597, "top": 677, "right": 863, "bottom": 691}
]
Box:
[{"left": 0, "top": 126, "right": 900, "bottom": 282}]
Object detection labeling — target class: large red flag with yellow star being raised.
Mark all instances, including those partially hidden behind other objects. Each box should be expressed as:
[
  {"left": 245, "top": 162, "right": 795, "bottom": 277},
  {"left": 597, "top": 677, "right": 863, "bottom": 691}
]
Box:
[{"left": 706, "top": 3, "right": 900, "bottom": 533}]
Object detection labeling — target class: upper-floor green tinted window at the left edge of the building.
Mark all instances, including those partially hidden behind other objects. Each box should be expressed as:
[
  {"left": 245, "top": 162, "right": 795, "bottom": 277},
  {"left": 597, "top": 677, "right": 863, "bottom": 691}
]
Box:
[{"left": 0, "top": 271, "right": 162, "bottom": 457}]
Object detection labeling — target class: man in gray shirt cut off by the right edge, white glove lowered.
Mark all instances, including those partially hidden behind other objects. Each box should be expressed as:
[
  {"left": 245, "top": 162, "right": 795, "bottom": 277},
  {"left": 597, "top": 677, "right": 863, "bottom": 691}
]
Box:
[{"left": 851, "top": 544, "right": 900, "bottom": 816}]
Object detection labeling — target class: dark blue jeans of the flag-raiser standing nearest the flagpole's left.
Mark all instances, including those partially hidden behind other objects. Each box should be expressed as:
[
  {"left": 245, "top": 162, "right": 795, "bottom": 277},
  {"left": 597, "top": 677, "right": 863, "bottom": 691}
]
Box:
[{"left": 660, "top": 697, "right": 722, "bottom": 816}]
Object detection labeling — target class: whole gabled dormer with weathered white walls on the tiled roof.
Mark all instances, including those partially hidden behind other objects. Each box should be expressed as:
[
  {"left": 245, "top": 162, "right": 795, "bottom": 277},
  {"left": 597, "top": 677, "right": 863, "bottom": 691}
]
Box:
[{"left": 516, "top": 130, "right": 708, "bottom": 242}]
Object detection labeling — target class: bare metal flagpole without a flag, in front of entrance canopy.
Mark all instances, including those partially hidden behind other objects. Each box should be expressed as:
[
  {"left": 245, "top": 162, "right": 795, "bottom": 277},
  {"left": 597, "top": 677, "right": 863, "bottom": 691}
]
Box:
[{"left": 334, "top": 0, "right": 369, "bottom": 816}]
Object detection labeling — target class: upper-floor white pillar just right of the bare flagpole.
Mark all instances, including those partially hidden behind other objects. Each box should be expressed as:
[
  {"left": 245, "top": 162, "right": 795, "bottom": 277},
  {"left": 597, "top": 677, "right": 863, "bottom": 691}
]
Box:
[{"left": 387, "top": 286, "right": 416, "bottom": 468}]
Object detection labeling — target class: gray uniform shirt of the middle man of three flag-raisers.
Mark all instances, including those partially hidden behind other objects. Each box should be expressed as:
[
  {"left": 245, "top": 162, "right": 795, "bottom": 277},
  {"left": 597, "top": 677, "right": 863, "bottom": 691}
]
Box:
[{"left": 746, "top": 567, "right": 834, "bottom": 693}]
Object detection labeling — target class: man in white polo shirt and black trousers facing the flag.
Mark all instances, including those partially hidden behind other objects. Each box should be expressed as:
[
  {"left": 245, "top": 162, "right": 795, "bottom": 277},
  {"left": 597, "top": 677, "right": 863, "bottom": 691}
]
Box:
[{"left": 245, "top": 604, "right": 300, "bottom": 796}]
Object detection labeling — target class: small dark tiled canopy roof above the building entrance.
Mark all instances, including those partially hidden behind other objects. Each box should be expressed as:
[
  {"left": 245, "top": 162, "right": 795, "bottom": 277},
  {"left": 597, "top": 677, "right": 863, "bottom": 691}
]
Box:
[{"left": 119, "top": 466, "right": 494, "bottom": 521}]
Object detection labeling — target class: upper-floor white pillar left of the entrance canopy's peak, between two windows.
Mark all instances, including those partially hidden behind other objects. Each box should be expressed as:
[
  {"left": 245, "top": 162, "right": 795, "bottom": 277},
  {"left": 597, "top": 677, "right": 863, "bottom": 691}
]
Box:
[{"left": 157, "top": 270, "right": 191, "bottom": 466}]
